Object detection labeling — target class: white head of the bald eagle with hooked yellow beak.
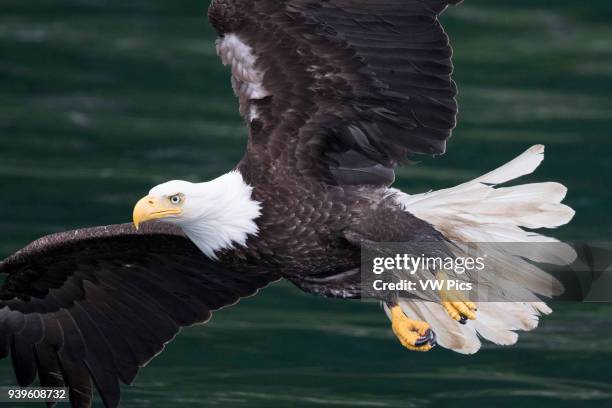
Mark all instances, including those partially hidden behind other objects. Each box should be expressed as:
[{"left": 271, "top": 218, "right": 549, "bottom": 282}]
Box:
[{"left": 134, "top": 171, "right": 261, "bottom": 259}]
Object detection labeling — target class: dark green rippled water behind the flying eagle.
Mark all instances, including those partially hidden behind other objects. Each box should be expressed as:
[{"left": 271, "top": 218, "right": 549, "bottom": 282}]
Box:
[{"left": 0, "top": 0, "right": 612, "bottom": 408}]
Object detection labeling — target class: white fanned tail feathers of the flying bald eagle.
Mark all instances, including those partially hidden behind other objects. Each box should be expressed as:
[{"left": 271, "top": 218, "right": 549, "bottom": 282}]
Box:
[{"left": 390, "top": 145, "right": 576, "bottom": 354}]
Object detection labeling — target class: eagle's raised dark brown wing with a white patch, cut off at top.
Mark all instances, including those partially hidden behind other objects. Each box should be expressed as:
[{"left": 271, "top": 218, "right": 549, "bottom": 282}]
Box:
[{"left": 209, "top": 0, "right": 460, "bottom": 185}]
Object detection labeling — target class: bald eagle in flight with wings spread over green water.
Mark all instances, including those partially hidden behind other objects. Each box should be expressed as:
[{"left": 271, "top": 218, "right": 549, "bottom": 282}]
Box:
[{"left": 0, "top": 0, "right": 573, "bottom": 407}]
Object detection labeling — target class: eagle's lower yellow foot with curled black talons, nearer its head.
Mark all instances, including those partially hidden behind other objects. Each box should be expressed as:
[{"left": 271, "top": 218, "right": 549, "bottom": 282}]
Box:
[{"left": 390, "top": 305, "right": 437, "bottom": 351}]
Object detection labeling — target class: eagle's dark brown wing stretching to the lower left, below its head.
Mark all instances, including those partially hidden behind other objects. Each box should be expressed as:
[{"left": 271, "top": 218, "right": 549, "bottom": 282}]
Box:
[{"left": 0, "top": 223, "right": 276, "bottom": 407}]
